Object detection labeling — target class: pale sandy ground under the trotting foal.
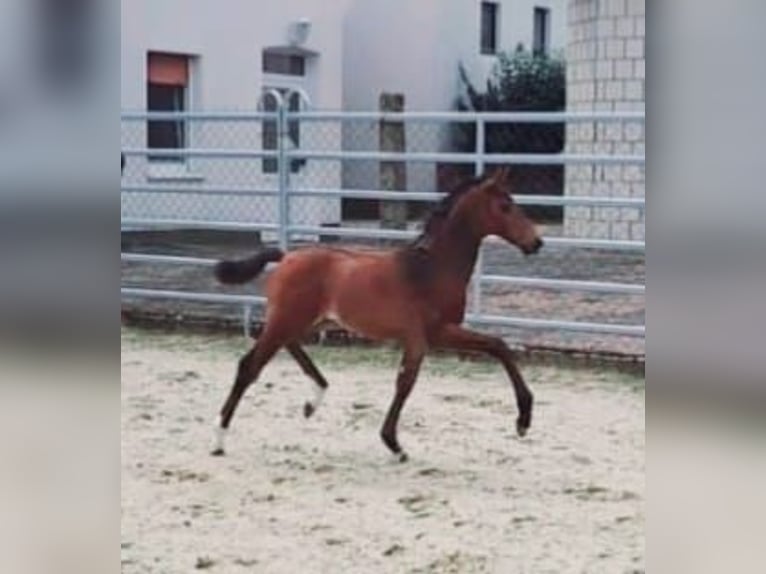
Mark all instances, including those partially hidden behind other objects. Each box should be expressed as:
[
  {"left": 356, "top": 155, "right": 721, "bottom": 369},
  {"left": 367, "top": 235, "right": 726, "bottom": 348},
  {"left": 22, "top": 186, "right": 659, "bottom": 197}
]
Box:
[{"left": 121, "top": 330, "right": 645, "bottom": 574}]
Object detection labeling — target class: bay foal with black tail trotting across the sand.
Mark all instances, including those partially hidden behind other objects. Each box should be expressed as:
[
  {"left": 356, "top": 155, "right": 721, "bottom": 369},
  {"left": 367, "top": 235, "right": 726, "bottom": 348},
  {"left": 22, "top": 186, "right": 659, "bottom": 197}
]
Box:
[{"left": 213, "top": 170, "right": 543, "bottom": 461}]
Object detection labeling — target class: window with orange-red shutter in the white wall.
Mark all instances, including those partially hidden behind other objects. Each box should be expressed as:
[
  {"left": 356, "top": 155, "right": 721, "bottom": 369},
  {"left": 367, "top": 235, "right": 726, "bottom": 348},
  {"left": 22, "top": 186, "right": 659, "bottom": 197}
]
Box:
[{"left": 146, "top": 52, "right": 189, "bottom": 163}]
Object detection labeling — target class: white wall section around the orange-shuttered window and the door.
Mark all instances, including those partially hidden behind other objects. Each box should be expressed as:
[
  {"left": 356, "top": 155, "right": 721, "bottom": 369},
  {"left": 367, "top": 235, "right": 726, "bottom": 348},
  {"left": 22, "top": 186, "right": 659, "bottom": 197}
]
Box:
[{"left": 121, "top": 0, "right": 352, "bottom": 232}]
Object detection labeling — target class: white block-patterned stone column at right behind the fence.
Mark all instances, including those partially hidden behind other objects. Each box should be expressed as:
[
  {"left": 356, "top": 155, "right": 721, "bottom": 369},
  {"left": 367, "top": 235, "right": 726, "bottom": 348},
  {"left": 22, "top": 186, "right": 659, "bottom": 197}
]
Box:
[{"left": 564, "top": 0, "right": 646, "bottom": 241}]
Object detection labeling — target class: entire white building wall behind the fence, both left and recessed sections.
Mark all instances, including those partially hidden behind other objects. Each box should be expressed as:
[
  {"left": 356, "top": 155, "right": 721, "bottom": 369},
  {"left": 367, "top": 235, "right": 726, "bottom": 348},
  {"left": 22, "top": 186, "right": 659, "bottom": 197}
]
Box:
[{"left": 121, "top": 0, "right": 566, "bottom": 224}]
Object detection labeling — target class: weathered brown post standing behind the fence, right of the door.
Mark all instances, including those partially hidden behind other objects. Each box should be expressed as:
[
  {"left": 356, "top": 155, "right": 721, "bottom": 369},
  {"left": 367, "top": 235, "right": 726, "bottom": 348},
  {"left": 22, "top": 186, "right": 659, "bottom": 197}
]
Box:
[{"left": 379, "top": 93, "right": 407, "bottom": 229}]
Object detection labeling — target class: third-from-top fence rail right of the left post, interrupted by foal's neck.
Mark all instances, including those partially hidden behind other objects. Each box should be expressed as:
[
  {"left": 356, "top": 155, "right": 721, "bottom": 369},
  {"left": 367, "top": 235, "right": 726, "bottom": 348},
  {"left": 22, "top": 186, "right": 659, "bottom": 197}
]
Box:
[{"left": 288, "top": 188, "right": 645, "bottom": 208}]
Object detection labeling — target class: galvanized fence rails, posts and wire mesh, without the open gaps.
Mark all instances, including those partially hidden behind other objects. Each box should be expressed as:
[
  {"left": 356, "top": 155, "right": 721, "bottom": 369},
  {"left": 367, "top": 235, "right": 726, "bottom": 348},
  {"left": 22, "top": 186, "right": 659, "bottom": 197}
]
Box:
[{"left": 121, "top": 105, "right": 645, "bottom": 348}]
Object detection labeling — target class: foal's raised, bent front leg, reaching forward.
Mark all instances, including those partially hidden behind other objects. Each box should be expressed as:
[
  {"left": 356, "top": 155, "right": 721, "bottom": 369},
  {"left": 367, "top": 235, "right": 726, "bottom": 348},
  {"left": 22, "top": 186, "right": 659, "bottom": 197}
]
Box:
[{"left": 431, "top": 325, "right": 534, "bottom": 436}]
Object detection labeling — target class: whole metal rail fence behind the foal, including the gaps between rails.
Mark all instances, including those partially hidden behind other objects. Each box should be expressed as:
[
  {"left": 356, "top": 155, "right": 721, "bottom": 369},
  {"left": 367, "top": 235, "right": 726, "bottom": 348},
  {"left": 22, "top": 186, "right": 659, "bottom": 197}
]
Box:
[{"left": 121, "top": 105, "right": 645, "bottom": 354}]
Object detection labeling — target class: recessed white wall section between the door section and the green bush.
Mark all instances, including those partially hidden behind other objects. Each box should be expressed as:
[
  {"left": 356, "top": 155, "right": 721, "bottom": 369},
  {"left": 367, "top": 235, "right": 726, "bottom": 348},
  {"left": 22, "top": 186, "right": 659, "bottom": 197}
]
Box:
[{"left": 343, "top": 0, "right": 566, "bottom": 196}]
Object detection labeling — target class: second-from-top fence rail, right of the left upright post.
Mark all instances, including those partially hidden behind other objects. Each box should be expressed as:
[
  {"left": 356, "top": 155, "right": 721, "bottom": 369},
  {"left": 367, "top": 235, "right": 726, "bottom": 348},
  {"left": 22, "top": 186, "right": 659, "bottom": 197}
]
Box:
[{"left": 284, "top": 149, "right": 645, "bottom": 165}]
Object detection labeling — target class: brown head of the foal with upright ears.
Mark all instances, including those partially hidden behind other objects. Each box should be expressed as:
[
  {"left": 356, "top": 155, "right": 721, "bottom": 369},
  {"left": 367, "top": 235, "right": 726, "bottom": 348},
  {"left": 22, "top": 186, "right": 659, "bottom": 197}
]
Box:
[{"left": 455, "top": 168, "right": 543, "bottom": 255}]
